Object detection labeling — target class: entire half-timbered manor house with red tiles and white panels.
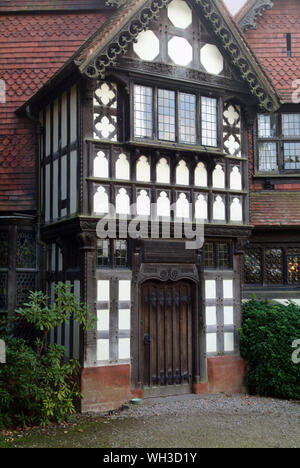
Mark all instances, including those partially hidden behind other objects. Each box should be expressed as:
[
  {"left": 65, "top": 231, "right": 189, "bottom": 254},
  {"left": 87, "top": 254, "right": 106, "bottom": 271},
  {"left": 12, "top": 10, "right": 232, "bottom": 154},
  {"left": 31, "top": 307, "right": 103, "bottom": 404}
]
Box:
[{"left": 0, "top": 0, "right": 300, "bottom": 411}]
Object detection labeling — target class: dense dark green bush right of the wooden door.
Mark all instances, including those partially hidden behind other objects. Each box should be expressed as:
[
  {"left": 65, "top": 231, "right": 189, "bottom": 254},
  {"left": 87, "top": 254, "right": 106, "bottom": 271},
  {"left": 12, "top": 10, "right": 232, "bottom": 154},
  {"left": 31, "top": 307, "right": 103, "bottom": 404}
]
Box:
[{"left": 240, "top": 298, "right": 300, "bottom": 399}]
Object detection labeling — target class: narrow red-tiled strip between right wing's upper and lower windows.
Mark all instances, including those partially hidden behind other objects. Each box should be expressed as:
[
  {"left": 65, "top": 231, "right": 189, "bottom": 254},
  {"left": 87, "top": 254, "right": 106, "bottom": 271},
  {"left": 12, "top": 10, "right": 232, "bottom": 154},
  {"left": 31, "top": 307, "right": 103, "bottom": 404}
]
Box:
[{"left": 250, "top": 192, "right": 300, "bottom": 226}]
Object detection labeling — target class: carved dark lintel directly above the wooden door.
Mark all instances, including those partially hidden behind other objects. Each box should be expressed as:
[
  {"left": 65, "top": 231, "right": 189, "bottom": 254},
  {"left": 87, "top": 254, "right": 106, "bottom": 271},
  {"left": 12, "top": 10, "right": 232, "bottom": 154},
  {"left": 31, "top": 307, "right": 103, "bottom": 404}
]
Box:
[{"left": 138, "top": 263, "right": 199, "bottom": 283}]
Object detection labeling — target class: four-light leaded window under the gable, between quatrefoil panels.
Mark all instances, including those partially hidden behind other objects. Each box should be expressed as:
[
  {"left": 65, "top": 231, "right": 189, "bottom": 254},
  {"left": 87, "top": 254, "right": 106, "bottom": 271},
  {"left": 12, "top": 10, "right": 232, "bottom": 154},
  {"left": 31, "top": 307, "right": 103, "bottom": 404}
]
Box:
[{"left": 133, "top": 85, "right": 218, "bottom": 147}]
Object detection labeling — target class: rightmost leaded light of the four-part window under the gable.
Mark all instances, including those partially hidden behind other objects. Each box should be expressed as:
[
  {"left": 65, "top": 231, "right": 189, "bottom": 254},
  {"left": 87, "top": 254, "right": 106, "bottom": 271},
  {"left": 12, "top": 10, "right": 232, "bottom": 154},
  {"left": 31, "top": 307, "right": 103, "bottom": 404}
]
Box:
[{"left": 201, "top": 96, "right": 218, "bottom": 146}]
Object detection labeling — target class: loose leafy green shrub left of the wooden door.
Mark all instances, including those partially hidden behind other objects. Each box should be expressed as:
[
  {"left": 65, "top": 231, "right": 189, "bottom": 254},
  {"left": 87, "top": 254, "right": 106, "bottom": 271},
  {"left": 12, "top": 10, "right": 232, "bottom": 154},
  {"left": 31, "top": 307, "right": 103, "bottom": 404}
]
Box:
[{"left": 0, "top": 283, "right": 94, "bottom": 429}]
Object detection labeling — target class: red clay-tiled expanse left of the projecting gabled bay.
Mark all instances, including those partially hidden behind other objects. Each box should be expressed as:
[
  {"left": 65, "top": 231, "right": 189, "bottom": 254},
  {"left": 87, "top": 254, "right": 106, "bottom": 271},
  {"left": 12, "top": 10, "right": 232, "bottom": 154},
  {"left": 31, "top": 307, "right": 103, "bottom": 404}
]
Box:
[{"left": 0, "top": 9, "right": 108, "bottom": 211}]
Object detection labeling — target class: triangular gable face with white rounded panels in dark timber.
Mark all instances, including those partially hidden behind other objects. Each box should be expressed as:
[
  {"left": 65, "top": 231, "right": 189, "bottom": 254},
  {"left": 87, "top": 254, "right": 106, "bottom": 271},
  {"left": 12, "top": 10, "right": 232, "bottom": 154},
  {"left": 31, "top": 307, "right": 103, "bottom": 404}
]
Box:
[{"left": 118, "top": 0, "right": 236, "bottom": 81}]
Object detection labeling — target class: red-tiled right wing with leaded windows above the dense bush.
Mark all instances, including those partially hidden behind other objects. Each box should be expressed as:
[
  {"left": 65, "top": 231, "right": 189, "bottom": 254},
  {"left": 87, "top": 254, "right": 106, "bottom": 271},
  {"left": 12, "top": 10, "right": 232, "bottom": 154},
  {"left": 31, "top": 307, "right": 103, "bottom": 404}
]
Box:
[{"left": 236, "top": 0, "right": 300, "bottom": 302}]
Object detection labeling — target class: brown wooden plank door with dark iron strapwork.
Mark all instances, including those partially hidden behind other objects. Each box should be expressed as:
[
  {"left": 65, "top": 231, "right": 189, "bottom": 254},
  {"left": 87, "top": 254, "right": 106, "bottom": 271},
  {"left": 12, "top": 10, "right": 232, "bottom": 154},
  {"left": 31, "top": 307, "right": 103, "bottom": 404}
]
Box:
[{"left": 141, "top": 281, "right": 192, "bottom": 397}]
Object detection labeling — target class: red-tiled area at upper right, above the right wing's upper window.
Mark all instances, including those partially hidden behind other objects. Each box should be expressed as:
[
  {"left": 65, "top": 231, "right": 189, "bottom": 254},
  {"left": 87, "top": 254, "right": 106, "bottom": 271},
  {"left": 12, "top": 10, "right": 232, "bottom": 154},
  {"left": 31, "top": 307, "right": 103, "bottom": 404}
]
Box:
[{"left": 245, "top": 0, "right": 300, "bottom": 101}]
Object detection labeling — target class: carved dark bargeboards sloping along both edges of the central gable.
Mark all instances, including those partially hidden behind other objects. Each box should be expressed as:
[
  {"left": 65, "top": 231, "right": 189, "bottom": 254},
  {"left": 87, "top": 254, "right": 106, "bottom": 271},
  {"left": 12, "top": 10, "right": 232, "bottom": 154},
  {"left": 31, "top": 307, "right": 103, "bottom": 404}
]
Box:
[{"left": 79, "top": 0, "right": 279, "bottom": 111}]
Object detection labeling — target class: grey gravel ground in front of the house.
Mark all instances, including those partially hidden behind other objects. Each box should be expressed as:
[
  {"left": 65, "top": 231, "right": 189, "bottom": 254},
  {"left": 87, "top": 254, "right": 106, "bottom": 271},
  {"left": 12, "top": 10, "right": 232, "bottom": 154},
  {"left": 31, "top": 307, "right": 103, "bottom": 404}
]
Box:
[{"left": 4, "top": 395, "right": 300, "bottom": 448}]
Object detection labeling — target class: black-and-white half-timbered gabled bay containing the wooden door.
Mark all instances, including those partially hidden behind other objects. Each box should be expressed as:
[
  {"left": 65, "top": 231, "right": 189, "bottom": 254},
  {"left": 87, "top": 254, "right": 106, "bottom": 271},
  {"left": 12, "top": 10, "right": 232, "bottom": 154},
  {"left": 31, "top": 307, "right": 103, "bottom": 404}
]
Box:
[{"left": 0, "top": 0, "right": 297, "bottom": 411}]
